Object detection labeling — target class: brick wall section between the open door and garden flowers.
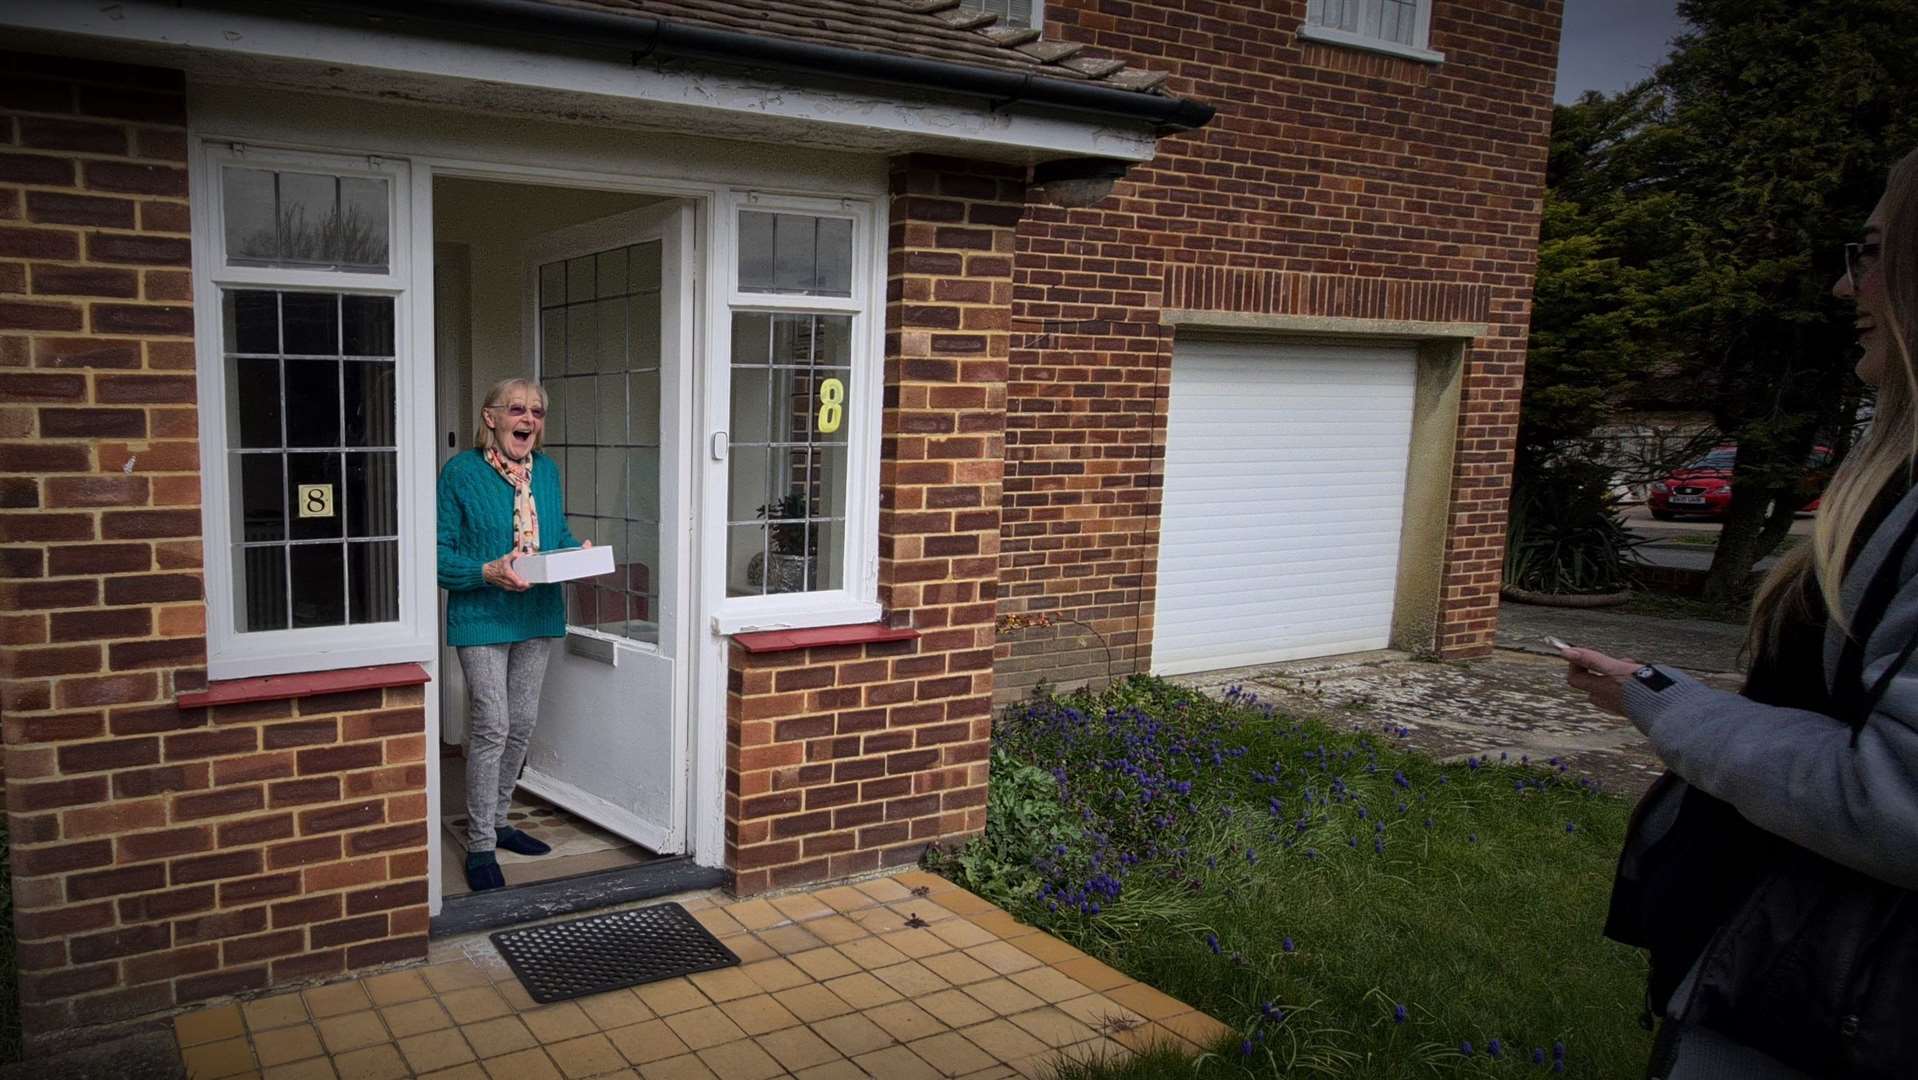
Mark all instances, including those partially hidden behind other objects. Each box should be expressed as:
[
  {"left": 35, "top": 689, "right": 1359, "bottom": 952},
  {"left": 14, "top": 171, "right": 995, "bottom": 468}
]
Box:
[{"left": 727, "top": 157, "right": 1024, "bottom": 894}]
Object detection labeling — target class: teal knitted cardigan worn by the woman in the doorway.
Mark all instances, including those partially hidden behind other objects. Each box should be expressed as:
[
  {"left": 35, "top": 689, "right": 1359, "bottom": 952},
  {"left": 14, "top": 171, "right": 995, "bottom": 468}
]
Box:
[{"left": 439, "top": 451, "right": 579, "bottom": 646}]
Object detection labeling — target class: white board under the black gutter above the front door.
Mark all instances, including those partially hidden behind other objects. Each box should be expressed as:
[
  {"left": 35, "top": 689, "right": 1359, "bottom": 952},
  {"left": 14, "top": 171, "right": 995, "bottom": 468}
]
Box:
[{"left": 0, "top": 0, "right": 1155, "bottom": 163}]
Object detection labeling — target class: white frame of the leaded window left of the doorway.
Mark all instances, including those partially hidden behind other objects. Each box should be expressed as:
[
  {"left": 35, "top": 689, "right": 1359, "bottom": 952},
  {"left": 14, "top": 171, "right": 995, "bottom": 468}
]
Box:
[{"left": 192, "top": 136, "right": 437, "bottom": 681}]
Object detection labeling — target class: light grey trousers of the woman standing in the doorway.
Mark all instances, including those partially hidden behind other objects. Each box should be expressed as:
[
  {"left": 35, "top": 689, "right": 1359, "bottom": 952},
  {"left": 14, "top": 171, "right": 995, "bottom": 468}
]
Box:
[{"left": 460, "top": 637, "right": 552, "bottom": 852}]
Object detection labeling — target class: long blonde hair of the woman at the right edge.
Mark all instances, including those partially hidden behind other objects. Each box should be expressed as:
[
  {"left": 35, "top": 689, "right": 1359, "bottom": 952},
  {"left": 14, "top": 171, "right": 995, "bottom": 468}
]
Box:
[{"left": 1747, "top": 150, "right": 1918, "bottom": 656}]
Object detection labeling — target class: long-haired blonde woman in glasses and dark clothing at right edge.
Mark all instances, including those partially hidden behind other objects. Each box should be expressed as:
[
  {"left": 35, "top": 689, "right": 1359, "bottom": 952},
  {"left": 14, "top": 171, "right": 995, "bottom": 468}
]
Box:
[{"left": 1565, "top": 153, "right": 1918, "bottom": 1080}]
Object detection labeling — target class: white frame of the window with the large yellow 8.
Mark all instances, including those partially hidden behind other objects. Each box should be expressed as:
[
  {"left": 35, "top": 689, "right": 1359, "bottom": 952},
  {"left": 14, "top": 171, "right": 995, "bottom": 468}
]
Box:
[{"left": 702, "top": 190, "right": 886, "bottom": 635}]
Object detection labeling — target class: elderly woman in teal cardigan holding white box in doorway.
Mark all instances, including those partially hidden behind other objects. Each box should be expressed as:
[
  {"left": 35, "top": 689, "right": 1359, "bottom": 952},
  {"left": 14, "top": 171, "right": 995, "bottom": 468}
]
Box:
[{"left": 439, "top": 378, "right": 593, "bottom": 892}]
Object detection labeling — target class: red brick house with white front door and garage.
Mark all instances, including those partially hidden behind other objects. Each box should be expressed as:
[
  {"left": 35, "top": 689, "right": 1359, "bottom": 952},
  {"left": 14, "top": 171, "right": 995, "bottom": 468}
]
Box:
[{"left": 0, "top": 0, "right": 1559, "bottom": 1036}]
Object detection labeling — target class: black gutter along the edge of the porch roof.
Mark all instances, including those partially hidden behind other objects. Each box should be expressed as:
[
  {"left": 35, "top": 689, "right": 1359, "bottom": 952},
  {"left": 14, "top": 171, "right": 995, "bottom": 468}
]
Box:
[{"left": 262, "top": 0, "right": 1216, "bottom": 132}]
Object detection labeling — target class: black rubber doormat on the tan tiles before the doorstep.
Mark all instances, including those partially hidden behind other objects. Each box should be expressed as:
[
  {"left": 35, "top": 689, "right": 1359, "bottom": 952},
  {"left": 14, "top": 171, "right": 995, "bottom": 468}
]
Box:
[{"left": 493, "top": 904, "right": 738, "bottom": 1005}]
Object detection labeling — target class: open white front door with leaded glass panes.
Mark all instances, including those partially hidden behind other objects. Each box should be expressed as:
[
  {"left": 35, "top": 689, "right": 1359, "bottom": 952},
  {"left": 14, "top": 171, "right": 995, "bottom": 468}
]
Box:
[{"left": 520, "top": 201, "right": 694, "bottom": 854}]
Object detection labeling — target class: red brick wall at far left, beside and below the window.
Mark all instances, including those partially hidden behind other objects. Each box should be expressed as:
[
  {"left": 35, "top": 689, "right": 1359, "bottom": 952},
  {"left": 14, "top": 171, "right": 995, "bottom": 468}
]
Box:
[{"left": 0, "top": 56, "right": 426, "bottom": 1032}]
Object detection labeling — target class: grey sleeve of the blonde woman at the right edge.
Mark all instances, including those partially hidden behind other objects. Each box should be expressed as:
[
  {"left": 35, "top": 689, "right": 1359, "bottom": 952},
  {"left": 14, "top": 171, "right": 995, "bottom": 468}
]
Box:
[{"left": 1625, "top": 598, "right": 1918, "bottom": 888}]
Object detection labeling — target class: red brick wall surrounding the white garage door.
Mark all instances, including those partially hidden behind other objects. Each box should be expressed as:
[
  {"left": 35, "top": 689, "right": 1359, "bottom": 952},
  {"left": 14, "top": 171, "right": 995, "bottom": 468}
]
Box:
[{"left": 997, "top": 0, "right": 1563, "bottom": 696}]
